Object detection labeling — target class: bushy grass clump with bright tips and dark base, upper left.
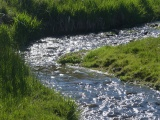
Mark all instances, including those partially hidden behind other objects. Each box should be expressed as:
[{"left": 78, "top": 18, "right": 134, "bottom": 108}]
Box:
[{"left": 13, "top": 13, "right": 41, "bottom": 46}]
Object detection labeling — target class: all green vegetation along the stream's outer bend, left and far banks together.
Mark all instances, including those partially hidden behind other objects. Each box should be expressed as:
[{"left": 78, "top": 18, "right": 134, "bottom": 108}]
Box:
[{"left": 0, "top": 0, "right": 160, "bottom": 120}]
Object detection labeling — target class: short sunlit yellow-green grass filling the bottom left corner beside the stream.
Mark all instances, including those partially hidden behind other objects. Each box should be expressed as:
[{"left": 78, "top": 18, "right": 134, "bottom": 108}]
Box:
[{"left": 0, "top": 83, "right": 78, "bottom": 120}]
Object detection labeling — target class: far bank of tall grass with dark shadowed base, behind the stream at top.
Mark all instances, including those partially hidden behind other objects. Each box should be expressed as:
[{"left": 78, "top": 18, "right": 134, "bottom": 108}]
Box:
[{"left": 1, "top": 0, "right": 160, "bottom": 35}]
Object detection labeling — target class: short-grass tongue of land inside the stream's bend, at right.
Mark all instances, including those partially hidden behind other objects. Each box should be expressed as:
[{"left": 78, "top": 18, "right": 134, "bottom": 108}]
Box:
[{"left": 59, "top": 37, "right": 160, "bottom": 90}]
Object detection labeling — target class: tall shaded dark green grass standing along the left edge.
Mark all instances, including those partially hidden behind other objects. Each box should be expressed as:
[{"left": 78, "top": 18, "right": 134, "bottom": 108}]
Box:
[{"left": 0, "top": 25, "right": 28, "bottom": 97}]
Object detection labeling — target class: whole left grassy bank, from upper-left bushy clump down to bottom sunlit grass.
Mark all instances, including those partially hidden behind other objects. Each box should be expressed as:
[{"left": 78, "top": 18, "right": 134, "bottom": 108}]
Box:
[{"left": 0, "top": 2, "right": 79, "bottom": 120}]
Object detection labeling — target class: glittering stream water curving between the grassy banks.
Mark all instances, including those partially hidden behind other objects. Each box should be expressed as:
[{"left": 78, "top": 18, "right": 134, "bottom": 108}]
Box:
[{"left": 24, "top": 22, "right": 160, "bottom": 120}]
